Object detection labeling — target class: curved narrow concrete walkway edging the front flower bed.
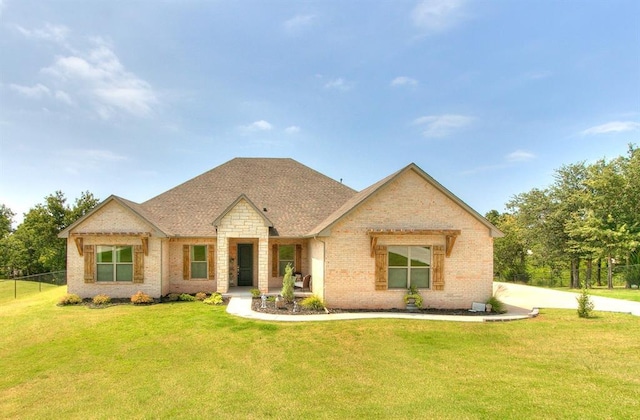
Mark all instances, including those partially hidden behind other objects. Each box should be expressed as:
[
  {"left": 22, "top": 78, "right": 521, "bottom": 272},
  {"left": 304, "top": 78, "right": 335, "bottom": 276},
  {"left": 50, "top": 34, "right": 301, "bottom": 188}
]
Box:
[{"left": 227, "top": 295, "right": 537, "bottom": 322}]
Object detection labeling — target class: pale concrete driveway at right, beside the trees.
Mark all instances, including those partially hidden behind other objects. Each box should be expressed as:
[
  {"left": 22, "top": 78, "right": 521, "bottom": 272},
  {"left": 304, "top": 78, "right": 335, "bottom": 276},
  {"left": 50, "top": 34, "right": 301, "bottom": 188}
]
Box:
[{"left": 493, "top": 282, "right": 640, "bottom": 316}]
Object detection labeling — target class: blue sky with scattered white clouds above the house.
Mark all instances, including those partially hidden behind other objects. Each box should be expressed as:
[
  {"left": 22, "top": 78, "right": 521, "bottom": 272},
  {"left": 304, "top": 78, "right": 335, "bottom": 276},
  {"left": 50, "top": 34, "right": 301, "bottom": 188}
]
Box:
[{"left": 0, "top": 0, "right": 640, "bottom": 225}]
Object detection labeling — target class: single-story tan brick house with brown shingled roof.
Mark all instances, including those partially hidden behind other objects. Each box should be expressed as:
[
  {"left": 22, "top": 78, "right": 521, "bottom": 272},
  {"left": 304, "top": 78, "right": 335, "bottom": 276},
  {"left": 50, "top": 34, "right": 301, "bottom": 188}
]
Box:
[{"left": 59, "top": 158, "right": 502, "bottom": 308}]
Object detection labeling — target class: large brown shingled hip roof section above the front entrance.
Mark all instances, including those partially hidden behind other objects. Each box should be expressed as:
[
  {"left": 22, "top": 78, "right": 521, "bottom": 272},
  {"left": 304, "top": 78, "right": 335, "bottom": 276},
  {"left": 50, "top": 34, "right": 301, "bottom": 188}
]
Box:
[{"left": 140, "top": 158, "right": 357, "bottom": 237}]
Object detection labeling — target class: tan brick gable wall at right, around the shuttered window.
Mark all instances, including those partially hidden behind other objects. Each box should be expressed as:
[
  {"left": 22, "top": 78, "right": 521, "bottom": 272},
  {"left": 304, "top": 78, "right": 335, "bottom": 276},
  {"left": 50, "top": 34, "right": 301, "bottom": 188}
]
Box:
[{"left": 320, "top": 171, "right": 493, "bottom": 308}]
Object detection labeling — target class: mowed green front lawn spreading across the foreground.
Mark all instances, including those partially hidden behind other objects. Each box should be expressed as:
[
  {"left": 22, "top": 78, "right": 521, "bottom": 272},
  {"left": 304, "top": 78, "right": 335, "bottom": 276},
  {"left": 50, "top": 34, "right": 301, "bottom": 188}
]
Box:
[{"left": 0, "top": 287, "right": 640, "bottom": 419}]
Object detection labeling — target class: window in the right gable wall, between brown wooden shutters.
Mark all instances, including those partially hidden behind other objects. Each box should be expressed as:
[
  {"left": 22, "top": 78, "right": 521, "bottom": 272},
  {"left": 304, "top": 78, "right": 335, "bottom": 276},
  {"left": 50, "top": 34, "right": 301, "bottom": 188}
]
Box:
[{"left": 387, "top": 246, "right": 431, "bottom": 289}]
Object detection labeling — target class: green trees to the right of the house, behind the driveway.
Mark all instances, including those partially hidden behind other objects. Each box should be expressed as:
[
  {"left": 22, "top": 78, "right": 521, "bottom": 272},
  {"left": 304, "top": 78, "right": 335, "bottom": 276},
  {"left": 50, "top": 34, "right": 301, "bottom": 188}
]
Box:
[{"left": 487, "top": 145, "right": 640, "bottom": 288}]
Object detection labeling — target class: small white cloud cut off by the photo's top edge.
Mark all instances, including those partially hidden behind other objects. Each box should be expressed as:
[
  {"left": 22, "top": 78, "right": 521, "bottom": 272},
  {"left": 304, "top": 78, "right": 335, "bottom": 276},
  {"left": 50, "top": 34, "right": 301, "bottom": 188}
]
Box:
[{"left": 411, "top": 0, "right": 465, "bottom": 32}]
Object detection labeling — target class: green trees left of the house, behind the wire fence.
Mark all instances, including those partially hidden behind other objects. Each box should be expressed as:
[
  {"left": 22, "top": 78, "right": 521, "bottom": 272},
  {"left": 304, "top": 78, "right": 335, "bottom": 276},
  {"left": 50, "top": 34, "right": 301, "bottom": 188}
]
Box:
[{"left": 0, "top": 191, "right": 99, "bottom": 278}]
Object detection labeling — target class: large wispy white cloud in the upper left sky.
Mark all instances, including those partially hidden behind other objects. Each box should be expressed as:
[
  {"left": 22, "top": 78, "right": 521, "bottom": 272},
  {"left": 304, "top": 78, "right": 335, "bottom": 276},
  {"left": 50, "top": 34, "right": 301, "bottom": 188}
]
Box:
[{"left": 41, "top": 39, "right": 159, "bottom": 119}]
